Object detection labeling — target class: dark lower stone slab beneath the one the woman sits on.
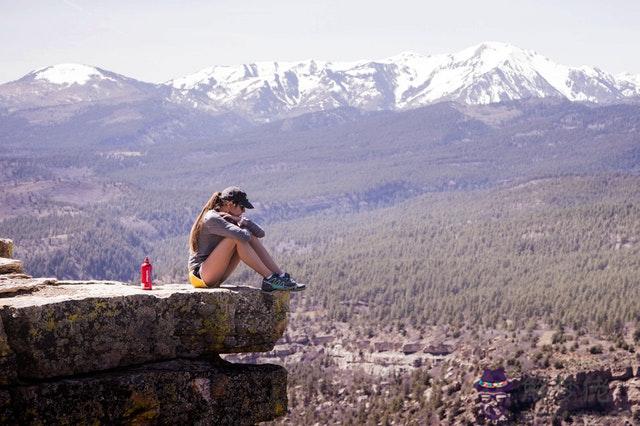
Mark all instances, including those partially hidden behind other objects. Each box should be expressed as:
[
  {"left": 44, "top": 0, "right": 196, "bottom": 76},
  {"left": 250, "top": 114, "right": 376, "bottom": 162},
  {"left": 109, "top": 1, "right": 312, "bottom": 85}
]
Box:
[{"left": 0, "top": 360, "right": 287, "bottom": 425}]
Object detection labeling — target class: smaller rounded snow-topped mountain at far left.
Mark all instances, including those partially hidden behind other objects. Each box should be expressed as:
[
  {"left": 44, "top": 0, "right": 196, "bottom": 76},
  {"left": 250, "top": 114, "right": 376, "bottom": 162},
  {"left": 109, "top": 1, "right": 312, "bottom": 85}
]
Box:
[{"left": 0, "top": 64, "right": 166, "bottom": 111}]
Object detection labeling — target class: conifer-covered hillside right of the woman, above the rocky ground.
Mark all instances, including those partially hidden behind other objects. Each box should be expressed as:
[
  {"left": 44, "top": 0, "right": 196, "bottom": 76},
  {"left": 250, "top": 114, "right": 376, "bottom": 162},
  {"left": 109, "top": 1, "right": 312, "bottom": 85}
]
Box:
[{"left": 258, "top": 176, "right": 640, "bottom": 333}]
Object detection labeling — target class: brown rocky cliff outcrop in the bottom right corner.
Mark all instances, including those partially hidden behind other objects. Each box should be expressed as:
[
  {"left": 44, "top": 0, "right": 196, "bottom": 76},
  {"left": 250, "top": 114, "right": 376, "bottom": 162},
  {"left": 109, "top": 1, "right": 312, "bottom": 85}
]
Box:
[{"left": 429, "top": 360, "right": 640, "bottom": 425}]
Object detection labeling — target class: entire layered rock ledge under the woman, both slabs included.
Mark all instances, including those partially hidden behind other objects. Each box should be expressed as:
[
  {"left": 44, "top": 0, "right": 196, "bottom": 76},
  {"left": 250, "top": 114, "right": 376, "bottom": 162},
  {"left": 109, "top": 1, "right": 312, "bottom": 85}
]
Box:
[{"left": 0, "top": 240, "right": 289, "bottom": 424}]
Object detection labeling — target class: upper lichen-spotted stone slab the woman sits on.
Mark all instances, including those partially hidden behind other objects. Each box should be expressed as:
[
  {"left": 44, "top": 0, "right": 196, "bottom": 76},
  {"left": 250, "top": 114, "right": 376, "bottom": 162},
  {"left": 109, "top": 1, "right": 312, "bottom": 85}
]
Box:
[{"left": 0, "top": 283, "right": 289, "bottom": 379}]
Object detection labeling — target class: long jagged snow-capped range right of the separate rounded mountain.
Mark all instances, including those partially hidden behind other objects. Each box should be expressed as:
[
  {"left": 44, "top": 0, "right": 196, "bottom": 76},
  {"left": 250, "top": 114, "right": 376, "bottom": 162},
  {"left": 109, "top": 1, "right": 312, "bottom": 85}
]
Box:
[{"left": 167, "top": 42, "right": 640, "bottom": 120}]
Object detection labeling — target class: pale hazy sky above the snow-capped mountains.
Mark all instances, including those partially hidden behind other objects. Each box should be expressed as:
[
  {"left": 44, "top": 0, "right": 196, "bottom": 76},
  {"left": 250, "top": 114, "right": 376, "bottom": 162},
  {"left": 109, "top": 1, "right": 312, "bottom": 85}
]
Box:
[{"left": 0, "top": 0, "right": 640, "bottom": 83}]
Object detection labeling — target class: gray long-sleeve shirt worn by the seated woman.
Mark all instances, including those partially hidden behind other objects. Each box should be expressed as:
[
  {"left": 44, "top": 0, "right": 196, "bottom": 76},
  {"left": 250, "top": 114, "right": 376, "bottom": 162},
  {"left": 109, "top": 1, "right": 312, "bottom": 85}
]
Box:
[{"left": 189, "top": 210, "right": 264, "bottom": 271}]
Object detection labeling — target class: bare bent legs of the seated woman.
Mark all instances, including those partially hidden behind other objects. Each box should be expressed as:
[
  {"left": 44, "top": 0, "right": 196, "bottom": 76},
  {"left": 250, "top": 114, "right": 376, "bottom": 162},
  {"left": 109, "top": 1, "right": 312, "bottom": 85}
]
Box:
[{"left": 200, "top": 238, "right": 274, "bottom": 285}]
